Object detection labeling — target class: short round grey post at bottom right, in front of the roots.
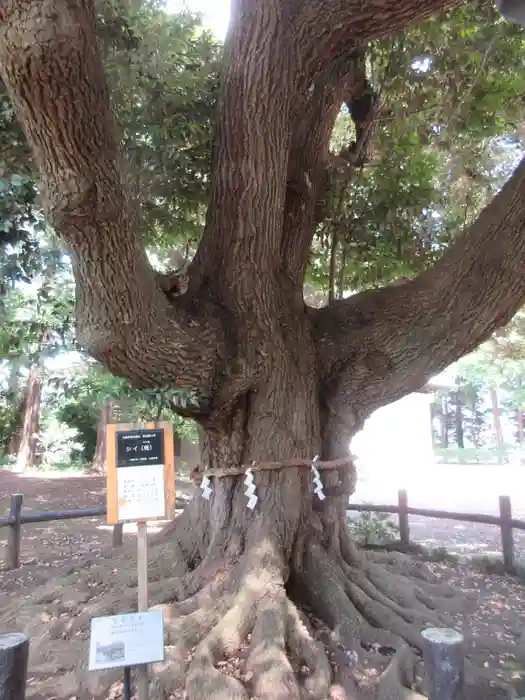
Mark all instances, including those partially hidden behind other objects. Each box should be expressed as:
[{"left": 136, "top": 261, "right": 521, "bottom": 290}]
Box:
[{"left": 421, "top": 627, "right": 465, "bottom": 700}]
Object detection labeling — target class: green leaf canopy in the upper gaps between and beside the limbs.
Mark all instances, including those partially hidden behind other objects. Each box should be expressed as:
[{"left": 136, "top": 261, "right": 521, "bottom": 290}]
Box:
[{"left": 0, "top": 2, "right": 524, "bottom": 291}]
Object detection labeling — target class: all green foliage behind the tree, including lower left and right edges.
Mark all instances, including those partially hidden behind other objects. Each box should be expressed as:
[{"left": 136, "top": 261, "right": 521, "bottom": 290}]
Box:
[{"left": 0, "top": 0, "right": 525, "bottom": 470}]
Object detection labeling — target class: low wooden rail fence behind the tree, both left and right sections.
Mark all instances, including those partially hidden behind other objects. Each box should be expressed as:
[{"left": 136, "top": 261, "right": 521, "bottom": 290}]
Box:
[{"left": 0, "top": 490, "right": 525, "bottom": 571}]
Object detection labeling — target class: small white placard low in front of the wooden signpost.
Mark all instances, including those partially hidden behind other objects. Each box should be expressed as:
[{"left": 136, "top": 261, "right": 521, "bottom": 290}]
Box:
[{"left": 89, "top": 610, "right": 164, "bottom": 671}]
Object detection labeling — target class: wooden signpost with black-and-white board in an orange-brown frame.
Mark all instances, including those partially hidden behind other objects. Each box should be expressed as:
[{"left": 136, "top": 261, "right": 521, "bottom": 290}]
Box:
[{"left": 106, "top": 423, "right": 175, "bottom": 700}]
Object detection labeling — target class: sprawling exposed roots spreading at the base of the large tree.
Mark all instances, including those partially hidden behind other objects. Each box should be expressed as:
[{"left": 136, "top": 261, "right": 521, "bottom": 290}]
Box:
[{"left": 0, "top": 506, "right": 516, "bottom": 700}]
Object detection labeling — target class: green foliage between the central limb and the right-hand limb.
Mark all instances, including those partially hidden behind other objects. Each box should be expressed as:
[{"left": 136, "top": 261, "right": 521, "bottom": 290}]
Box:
[{"left": 315, "top": 3, "right": 525, "bottom": 292}]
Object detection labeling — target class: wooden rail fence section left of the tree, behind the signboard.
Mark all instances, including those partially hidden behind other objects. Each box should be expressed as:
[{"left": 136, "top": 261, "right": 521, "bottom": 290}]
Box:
[{"left": 0, "top": 493, "right": 188, "bottom": 571}]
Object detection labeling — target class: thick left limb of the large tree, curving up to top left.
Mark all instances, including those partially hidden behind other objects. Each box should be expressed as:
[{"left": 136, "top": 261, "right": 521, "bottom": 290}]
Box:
[{"left": 0, "top": 0, "right": 220, "bottom": 402}]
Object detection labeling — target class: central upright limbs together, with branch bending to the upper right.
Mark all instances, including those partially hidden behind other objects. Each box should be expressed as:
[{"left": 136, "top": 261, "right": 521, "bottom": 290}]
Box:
[{"left": 190, "top": 0, "right": 453, "bottom": 296}]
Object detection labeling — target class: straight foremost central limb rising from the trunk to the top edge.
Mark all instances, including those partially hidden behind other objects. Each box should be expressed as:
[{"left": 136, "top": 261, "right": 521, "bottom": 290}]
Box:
[{"left": 188, "top": 0, "right": 297, "bottom": 306}]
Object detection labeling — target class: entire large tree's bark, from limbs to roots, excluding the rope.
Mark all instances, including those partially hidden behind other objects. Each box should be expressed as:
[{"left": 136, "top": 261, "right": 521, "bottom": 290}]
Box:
[{"left": 0, "top": 0, "right": 525, "bottom": 700}]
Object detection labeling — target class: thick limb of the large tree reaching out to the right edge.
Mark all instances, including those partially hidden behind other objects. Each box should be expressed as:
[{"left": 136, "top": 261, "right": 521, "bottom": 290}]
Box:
[{"left": 310, "top": 155, "right": 525, "bottom": 432}]
